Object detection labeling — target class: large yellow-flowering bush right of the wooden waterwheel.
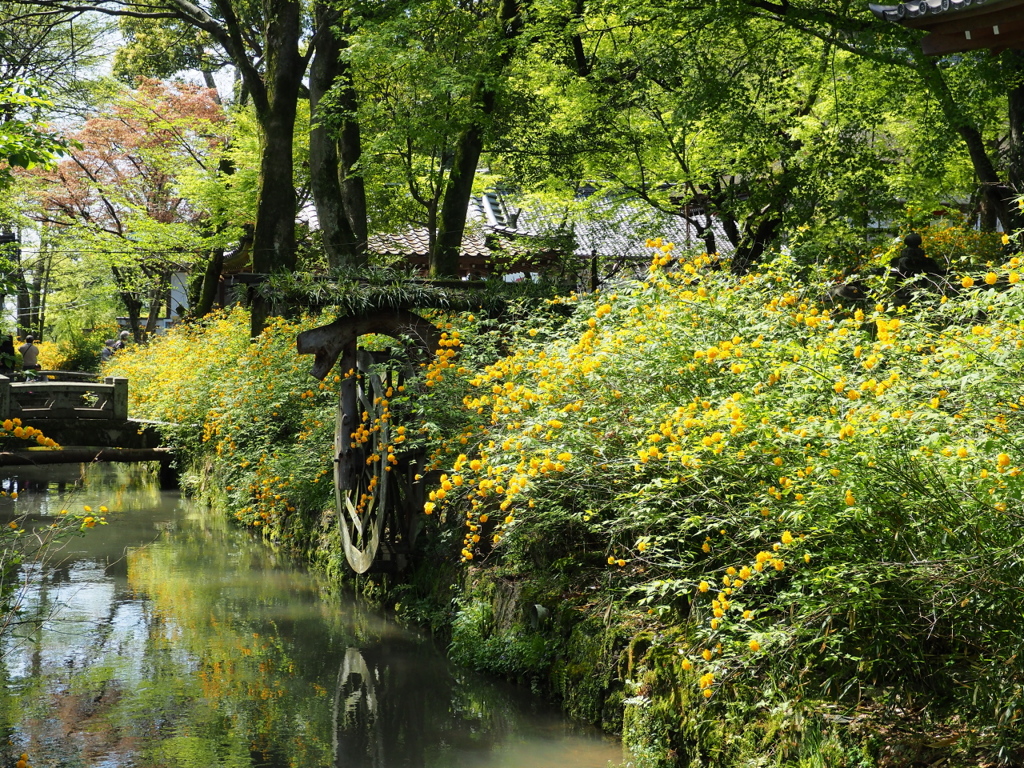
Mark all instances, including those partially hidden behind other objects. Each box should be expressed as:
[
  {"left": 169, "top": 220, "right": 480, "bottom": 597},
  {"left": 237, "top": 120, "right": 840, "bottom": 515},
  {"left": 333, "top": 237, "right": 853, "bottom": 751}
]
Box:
[{"left": 417, "top": 242, "right": 1024, "bottom": 764}]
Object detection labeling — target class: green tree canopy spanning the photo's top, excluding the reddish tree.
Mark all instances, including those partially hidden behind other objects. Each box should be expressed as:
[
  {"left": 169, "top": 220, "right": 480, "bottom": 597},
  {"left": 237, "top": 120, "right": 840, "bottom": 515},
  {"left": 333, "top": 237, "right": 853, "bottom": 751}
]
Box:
[{"left": 0, "top": 0, "right": 1024, "bottom": 333}]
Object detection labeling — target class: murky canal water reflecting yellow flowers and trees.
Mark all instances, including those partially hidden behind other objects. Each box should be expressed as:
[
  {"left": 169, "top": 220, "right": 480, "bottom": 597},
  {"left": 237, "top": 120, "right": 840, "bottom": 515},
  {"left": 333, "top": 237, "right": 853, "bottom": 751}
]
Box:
[{"left": 0, "top": 466, "right": 623, "bottom": 768}]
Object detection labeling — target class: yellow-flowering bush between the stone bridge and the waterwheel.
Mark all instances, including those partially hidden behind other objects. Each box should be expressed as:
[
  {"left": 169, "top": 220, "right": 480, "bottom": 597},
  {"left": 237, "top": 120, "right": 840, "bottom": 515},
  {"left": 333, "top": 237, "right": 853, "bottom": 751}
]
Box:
[{"left": 103, "top": 308, "right": 340, "bottom": 539}]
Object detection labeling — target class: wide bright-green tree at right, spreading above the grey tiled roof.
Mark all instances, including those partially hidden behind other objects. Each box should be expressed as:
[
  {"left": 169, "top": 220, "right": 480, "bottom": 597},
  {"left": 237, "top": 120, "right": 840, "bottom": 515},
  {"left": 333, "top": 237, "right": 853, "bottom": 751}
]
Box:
[{"left": 490, "top": 0, "right": 1013, "bottom": 271}]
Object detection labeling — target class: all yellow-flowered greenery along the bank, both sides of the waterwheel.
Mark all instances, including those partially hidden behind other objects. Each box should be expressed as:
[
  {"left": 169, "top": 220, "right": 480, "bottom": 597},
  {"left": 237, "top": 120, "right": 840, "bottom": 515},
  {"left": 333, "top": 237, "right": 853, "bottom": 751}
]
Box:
[{"left": 109, "top": 242, "right": 1024, "bottom": 768}]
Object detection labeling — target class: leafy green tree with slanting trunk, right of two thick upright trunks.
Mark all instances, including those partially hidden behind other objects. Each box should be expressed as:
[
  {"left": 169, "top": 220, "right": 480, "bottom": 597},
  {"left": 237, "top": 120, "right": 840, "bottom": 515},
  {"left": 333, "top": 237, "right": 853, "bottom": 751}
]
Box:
[{"left": 335, "top": 0, "right": 523, "bottom": 276}]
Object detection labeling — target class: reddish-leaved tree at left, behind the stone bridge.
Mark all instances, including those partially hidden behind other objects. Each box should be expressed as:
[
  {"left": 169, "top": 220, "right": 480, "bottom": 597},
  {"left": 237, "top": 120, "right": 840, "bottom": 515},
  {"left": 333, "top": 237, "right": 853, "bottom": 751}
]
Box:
[{"left": 23, "top": 81, "right": 237, "bottom": 340}]
